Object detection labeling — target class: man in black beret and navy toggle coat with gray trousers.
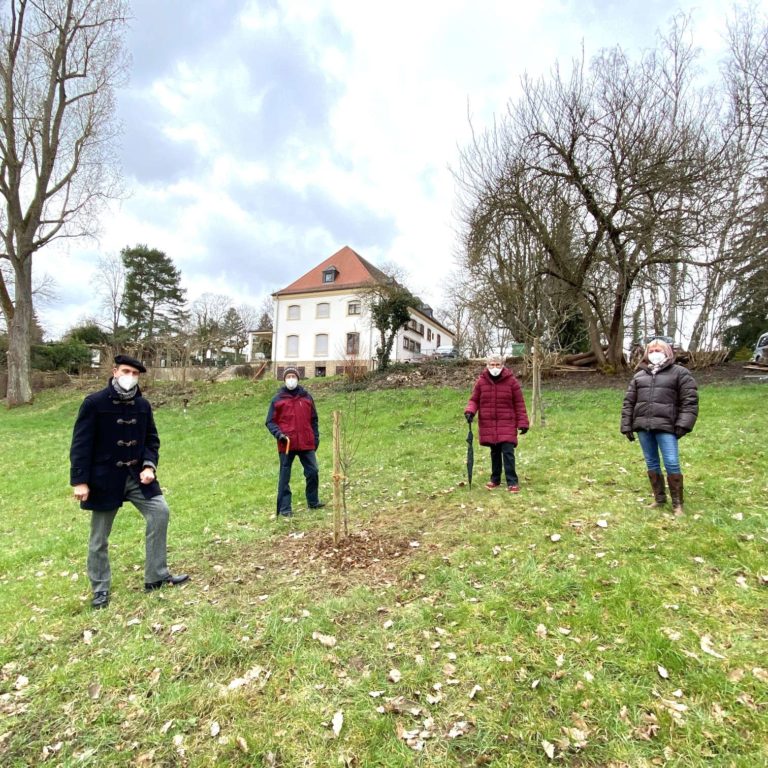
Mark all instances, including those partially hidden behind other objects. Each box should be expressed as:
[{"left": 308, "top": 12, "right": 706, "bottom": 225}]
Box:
[{"left": 69, "top": 355, "right": 189, "bottom": 608}]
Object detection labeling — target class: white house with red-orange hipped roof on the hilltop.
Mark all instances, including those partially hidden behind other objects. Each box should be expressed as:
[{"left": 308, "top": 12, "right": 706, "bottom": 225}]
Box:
[{"left": 262, "top": 246, "right": 454, "bottom": 378}]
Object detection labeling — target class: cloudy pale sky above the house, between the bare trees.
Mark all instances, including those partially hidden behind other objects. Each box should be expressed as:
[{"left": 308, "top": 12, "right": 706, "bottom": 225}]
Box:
[{"left": 35, "top": 0, "right": 736, "bottom": 338}]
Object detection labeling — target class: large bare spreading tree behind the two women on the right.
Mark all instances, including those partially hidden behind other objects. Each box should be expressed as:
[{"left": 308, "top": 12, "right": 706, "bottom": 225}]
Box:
[{"left": 459, "top": 20, "right": 721, "bottom": 367}]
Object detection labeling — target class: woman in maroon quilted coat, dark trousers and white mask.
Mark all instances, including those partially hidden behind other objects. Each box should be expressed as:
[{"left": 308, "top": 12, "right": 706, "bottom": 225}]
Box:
[{"left": 464, "top": 355, "right": 529, "bottom": 493}]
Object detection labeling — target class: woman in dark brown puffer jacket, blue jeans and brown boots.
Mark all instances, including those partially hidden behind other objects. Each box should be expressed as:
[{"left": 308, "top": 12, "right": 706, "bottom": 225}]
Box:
[{"left": 621, "top": 339, "right": 699, "bottom": 515}]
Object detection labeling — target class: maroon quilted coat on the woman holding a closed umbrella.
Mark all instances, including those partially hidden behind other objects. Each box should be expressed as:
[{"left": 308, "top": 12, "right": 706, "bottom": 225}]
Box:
[{"left": 464, "top": 368, "right": 529, "bottom": 445}]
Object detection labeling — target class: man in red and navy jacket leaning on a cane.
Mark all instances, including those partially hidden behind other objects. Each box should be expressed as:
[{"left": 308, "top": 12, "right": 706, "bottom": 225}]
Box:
[{"left": 266, "top": 367, "right": 325, "bottom": 517}]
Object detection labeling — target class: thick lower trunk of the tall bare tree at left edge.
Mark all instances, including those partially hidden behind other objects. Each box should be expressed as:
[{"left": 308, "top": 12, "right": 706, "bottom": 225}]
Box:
[{"left": 5, "top": 259, "right": 34, "bottom": 408}]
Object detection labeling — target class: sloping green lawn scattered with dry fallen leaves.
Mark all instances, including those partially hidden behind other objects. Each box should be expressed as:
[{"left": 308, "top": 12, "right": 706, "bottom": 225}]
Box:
[{"left": 0, "top": 382, "right": 768, "bottom": 768}]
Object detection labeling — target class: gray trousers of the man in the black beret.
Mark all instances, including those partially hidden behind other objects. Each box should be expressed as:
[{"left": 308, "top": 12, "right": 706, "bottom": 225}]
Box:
[{"left": 88, "top": 477, "right": 170, "bottom": 592}]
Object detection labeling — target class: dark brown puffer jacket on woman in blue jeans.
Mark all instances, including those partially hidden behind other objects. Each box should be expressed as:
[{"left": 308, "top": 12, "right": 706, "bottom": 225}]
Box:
[{"left": 621, "top": 361, "right": 699, "bottom": 437}]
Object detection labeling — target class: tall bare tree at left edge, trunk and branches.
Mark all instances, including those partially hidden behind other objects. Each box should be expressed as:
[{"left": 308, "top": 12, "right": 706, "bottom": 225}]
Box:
[{"left": 0, "top": 0, "right": 127, "bottom": 407}]
